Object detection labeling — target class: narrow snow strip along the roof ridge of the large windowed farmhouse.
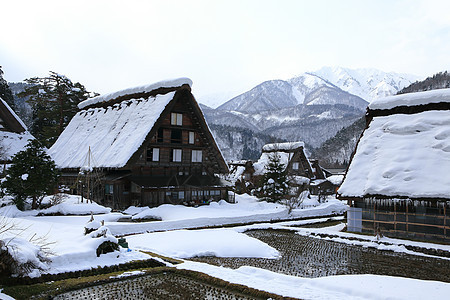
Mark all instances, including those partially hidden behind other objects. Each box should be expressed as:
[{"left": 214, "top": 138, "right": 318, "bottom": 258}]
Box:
[{"left": 78, "top": 77, "right": 192, "bottom": 109}]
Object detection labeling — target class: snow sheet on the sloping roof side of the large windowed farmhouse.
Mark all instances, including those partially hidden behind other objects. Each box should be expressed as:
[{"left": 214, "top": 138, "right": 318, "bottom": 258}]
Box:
[{"left": 48, "top": 92, "right": 175, "bottom": 168}]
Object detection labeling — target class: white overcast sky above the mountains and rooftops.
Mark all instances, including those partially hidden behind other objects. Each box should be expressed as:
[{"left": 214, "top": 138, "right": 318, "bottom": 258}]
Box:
[{"left": 0, "top": 0, "right": 450, "bottom": 105}]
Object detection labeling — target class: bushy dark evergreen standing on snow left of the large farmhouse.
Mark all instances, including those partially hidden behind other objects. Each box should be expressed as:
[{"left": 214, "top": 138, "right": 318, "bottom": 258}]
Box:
[{"left": 2, "top": 140, "right": 59, "bottom": 210}]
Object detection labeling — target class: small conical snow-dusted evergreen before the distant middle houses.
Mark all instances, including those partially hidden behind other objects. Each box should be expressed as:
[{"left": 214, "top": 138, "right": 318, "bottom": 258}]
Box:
[{"left": 261, "top": 153, "right": 289, "bottom": 202}]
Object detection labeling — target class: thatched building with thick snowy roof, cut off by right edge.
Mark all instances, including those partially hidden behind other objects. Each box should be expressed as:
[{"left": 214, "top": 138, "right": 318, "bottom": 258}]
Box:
[{"left": 338, "top": 89, "right": 450, "bottom": 242}]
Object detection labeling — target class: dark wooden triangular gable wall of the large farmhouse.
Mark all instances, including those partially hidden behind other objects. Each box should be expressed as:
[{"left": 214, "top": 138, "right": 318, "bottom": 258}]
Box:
[{"left": 126, "top": 85, "right": 228, "bottom": 176}]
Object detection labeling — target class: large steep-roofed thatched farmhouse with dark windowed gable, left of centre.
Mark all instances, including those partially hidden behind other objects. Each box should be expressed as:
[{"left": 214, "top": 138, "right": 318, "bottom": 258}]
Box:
[{"left": 49, "top": 78, "right": 232, "bottom": 208}]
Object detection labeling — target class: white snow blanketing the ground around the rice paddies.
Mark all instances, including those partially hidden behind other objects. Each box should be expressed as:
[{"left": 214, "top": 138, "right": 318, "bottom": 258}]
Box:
[{"left": 0, "top": 195, "right": 450, "bottom": 299}]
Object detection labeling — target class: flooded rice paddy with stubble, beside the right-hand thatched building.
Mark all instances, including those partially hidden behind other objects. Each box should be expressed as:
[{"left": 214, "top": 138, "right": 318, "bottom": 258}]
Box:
[{"left": 193, "top": 230, "right": 450, "bottom": 282}]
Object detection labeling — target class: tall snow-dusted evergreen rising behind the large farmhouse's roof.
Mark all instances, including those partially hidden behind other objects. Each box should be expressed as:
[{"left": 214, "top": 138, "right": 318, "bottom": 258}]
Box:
[{"left": 19, "top": 71, "right": 95, "bottom": 147}]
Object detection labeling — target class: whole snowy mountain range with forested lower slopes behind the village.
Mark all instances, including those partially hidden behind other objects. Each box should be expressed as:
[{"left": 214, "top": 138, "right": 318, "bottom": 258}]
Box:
[{"left": 203, "top": 67, "right": 417, "bottom": 160}]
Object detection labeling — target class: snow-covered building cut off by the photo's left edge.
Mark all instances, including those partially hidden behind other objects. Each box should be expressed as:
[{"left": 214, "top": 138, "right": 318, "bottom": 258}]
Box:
[{"left": 0, "top": 98, "right": 34, "bottom": 168}]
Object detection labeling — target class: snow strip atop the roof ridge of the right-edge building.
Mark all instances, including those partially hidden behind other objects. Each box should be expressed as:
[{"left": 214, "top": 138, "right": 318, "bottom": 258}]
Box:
[{"left": 369, "top": 89, "right": 450, "bottom": 109}]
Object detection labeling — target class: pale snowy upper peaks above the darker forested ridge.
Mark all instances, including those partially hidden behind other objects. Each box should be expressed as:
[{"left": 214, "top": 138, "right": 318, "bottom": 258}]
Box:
[{"left": 217, "top": 67, "right": 419, "bottom": 112}]
